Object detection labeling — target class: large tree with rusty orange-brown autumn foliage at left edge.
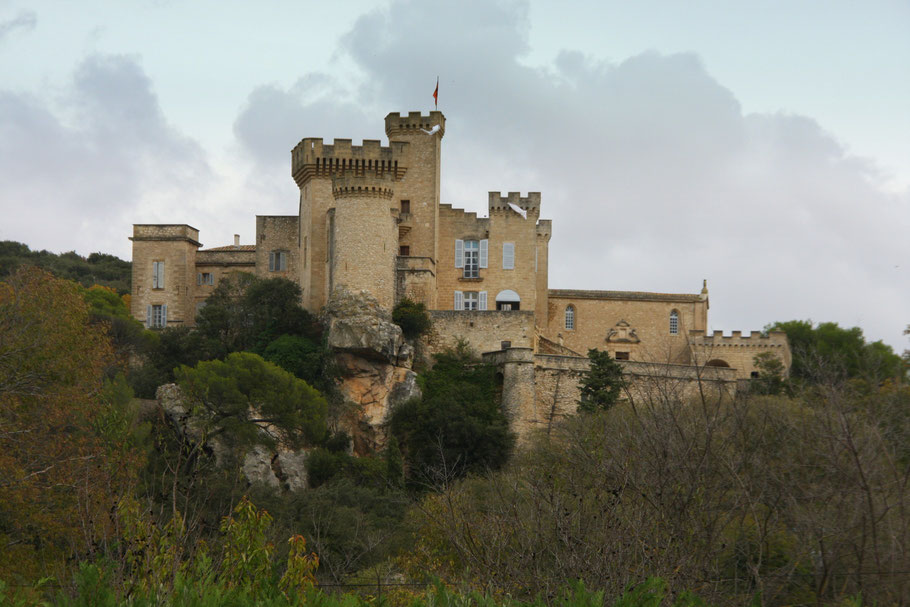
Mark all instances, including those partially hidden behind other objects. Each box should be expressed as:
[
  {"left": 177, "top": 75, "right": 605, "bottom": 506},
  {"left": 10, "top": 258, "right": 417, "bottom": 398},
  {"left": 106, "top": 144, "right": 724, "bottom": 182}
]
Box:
[{"left": 0, "top": 268, "right": 139, "bottom": 579}]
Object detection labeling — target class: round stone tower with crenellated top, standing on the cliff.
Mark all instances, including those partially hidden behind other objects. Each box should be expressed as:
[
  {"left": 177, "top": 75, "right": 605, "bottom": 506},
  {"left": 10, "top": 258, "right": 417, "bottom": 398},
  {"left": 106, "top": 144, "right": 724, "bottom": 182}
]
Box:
[{"left": 329, "top": 173, "right": 398, "bottom": 310}]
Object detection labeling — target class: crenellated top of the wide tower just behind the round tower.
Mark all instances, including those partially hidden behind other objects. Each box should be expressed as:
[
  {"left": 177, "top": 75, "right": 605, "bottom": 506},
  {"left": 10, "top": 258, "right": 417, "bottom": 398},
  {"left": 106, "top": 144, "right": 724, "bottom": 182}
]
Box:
[{"left": 291, "top": 137, "right": 408, "bottom": 187}]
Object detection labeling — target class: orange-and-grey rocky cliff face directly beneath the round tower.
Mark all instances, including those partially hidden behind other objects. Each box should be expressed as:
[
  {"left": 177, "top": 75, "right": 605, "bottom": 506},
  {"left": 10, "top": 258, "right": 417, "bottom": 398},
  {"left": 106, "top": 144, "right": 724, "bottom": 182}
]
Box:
[{"left": 321, "top": 289, "right": 420, "bottom": 455}]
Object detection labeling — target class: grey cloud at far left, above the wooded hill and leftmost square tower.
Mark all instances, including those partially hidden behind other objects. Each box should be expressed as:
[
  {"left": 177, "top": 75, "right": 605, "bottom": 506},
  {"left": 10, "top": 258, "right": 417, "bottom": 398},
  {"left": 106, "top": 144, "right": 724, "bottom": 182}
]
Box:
[{"left": 0, "top": 55, "right": 212, "bottom": 255}]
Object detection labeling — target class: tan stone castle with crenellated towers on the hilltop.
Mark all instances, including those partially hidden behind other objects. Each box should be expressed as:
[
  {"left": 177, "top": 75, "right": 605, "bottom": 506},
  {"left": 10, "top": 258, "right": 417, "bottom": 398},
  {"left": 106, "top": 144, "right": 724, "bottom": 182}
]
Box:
[{"left": 131, "top": 111, "right": 790, "bottom": 432}]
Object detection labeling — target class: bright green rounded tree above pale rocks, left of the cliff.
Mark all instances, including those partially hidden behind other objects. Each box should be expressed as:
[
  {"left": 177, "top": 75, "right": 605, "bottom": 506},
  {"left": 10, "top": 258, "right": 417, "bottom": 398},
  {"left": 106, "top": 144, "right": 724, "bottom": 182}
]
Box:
[{"left": 175, "top": 352, "right": 327, "bottom": 446}]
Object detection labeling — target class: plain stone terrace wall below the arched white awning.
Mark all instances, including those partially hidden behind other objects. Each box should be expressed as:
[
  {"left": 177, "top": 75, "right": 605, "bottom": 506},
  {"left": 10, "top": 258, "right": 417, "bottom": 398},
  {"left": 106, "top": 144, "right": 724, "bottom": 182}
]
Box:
[{"left": 423, "top": 310, "right": 535, "bottom": 354}]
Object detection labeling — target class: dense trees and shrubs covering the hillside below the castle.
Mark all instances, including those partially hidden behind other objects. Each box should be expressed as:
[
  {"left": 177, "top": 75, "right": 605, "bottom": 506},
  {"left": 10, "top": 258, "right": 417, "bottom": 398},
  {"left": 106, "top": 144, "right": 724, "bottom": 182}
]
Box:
[{"left": 0, "top": 268, "right": 910, "bottom": 607}]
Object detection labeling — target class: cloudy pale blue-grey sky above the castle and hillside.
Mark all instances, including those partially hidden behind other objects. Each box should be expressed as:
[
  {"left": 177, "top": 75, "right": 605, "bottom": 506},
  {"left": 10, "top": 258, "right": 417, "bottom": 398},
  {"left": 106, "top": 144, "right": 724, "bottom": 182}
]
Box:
[{"left": 0, "top": 0, "right": 910, "bottom": 352}]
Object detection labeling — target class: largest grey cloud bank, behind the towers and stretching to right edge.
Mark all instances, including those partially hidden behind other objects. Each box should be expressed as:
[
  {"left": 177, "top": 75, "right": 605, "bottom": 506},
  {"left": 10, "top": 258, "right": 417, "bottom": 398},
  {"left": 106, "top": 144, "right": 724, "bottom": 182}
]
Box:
[{"left": 235, "top": 0, "right": 910, "bottom": 347}]
